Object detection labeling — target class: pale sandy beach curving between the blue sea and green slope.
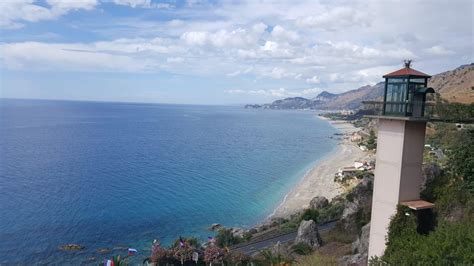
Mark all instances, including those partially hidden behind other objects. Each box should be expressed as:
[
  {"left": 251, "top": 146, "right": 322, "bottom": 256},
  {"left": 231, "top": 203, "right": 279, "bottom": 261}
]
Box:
[{"left": 271, "top": 117, "right": 368, "bottom": 217}]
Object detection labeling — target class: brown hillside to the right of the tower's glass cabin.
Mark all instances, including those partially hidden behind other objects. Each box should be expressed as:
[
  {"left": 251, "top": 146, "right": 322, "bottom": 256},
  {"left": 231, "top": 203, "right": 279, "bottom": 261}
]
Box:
[{"left": 428, "top": 63, "right": 474, "bottom": 103}]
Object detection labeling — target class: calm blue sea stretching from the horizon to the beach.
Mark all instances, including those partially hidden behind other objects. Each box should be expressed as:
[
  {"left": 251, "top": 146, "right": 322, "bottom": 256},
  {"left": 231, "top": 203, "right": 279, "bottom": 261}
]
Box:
[{"left": 0, "top": 99, "right": 337, "bottom": 265}]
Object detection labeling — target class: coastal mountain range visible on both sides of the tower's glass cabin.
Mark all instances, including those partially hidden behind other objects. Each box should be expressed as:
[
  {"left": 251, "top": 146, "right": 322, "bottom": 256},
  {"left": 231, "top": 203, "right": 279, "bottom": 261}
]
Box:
[{"left": 245, "top": 63, "right": 474, "bottom": 110}]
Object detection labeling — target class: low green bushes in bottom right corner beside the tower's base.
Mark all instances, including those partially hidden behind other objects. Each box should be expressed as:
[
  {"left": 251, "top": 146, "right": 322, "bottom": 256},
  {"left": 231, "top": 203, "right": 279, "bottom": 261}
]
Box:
[{"left": 378, "top": 207, "right": 474, "bottom": 265}]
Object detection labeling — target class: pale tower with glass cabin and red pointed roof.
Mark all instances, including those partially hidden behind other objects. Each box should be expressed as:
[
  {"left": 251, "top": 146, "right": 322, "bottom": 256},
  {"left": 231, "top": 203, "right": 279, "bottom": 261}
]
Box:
[{"left": 367, "top": 61, "right": 434, "bottom": 258}]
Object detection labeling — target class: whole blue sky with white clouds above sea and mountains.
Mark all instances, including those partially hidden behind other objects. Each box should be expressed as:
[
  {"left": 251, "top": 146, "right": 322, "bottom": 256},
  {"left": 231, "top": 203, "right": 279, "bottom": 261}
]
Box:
[{"left": 0, "top": 0, "right": 474, "bottom": 104}]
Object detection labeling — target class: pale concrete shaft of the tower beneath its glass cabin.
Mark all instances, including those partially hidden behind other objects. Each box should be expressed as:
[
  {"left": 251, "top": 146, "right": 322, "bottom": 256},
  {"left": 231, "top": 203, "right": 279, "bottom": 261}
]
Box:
[{"left": 369, "top": 118, "right": 426, "bottom": 259}]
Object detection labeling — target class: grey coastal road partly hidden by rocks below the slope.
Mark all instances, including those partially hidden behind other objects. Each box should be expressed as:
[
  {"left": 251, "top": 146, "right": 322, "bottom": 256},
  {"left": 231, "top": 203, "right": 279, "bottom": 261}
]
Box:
[{"left": 231, "top": 221, "right": 337, "bottom": 255}]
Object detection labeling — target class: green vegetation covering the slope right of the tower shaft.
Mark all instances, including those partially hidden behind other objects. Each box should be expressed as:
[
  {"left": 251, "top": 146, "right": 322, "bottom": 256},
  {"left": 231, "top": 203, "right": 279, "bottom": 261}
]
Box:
[{"left": 371, "top": 126, "right": 474, "bottom": 265}]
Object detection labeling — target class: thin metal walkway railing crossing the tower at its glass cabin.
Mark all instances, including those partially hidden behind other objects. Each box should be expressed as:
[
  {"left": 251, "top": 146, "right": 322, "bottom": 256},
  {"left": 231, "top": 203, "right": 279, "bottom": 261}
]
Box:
[{"left": 362, "top": 101, "right": 474, "bottom": 123}]
